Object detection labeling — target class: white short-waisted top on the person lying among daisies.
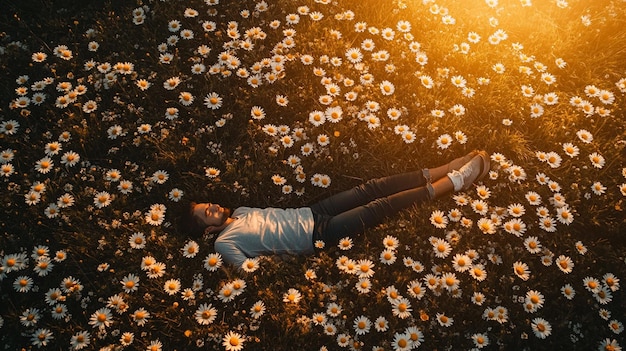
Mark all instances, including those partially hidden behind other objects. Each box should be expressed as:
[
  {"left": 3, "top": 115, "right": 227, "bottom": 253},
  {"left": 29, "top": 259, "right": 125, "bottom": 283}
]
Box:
[{"left": 215, "top": 207, "right": 314, "bottom": 267}]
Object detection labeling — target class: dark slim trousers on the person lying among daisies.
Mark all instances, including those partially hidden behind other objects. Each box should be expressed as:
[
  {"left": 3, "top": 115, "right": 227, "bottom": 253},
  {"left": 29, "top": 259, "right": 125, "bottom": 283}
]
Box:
[{"left": 310, "top": 171, "right": 429, "bottom": 247}]
